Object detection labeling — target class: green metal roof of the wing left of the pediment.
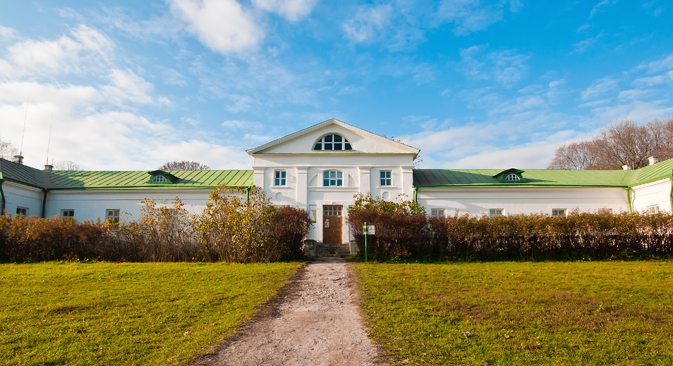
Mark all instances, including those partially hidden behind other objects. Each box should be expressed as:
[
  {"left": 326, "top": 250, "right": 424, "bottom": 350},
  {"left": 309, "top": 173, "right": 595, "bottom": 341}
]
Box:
[{"left": 0, "top": 159, "right": 253, "bottom": 190}]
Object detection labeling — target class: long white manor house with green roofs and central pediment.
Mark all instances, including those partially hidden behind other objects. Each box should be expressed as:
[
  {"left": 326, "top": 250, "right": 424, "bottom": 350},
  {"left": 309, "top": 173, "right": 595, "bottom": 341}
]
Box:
[{"left": 0, "top": 119, "right": 673, "bottom": 244}]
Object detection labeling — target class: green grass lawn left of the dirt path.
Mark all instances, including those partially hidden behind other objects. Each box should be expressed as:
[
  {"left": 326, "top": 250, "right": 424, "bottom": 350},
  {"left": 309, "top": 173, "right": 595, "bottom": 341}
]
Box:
[{"left": 0, "top": 262, "right": 301, "bottom": 365}]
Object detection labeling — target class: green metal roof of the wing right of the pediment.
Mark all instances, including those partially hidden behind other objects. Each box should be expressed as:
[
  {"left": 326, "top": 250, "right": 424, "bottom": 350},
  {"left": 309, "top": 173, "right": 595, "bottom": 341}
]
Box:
[{"left": 414, "top": 159, "right": 673, "bottom": 188}]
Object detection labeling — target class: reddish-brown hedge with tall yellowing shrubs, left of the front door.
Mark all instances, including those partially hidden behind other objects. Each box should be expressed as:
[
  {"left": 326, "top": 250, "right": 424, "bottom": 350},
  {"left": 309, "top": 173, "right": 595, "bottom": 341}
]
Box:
[{"left": 0, "top": 187, "right": 310, "bottom": 262}]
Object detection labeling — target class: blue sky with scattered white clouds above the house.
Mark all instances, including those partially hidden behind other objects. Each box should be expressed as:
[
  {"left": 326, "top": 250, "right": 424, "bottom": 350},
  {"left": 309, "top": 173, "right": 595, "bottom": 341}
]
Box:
[{"left": 0, "top": 0, "right": 673, "bottom": 170}]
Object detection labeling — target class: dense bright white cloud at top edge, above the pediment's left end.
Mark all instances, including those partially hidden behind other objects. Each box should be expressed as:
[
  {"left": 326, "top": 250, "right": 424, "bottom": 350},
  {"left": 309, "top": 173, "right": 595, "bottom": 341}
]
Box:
[{"left": 171, "top": 0, "right": 264, "bottom": 55}]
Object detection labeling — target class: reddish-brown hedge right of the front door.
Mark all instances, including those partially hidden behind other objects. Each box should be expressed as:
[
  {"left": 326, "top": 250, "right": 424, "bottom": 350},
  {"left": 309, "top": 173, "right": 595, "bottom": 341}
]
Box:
[{"left": 349, "top": 196, "right": 673, "bottom": 261}]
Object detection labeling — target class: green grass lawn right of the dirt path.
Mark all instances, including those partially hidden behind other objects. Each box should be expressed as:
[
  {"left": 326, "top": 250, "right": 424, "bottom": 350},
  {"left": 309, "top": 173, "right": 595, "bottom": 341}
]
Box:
[{"left": 355, "top": 261, "right": 673, "bottom": 365}]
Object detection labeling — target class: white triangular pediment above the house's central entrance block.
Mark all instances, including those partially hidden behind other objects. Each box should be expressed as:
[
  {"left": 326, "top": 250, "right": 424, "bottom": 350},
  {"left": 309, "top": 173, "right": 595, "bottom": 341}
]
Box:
[{"left": 246, "top": 119, "right": 420, "bottom": 156}]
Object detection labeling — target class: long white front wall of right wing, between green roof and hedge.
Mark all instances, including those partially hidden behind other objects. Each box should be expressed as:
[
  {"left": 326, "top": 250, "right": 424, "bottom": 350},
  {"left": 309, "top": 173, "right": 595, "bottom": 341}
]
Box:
[{"left": 418, "top": 187, "right": 629, "bottom": 215}]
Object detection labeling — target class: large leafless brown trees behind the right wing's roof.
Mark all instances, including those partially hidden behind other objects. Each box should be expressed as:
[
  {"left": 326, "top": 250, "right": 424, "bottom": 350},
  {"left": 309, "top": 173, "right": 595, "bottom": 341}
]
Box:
[{"left": 547, "top": 118, "right": 673, "bottom": 170}]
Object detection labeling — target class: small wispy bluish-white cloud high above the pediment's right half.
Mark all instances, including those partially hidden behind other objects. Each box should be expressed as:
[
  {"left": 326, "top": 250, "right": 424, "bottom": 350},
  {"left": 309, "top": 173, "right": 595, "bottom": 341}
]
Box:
[{"left": 342, "top": 4, "right": 393, "bottom": 43}]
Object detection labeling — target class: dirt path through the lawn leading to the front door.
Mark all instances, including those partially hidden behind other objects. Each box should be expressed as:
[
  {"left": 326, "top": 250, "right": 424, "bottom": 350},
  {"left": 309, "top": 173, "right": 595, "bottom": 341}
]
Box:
[{"left": 200, "top": 258, "right": 386, "bottom": 365}]
